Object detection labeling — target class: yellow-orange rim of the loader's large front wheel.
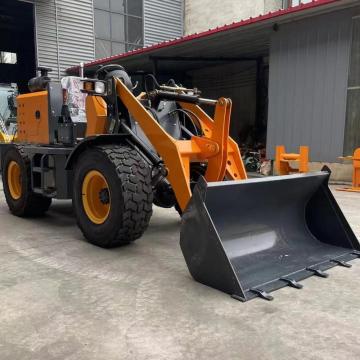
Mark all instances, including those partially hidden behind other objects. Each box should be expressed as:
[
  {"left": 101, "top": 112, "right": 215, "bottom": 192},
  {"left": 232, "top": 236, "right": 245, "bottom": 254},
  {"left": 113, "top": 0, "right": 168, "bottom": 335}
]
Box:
[{"left": 82, "top": 170, "right": 110, "bottom": 225}]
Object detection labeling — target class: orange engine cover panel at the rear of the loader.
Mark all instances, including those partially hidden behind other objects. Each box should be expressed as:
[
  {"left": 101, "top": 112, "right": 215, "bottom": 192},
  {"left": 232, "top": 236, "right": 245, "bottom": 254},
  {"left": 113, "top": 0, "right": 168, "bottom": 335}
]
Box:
[{"left": 15, "top": 91, "right": 49, "bottom": 144}]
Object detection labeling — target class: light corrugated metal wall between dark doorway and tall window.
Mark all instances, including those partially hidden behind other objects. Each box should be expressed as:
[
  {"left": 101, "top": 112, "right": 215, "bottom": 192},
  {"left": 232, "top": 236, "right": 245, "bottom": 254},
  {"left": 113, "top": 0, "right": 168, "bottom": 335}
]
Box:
[{"left": 35, "top": 0, "right": 95, "bottom": 79}]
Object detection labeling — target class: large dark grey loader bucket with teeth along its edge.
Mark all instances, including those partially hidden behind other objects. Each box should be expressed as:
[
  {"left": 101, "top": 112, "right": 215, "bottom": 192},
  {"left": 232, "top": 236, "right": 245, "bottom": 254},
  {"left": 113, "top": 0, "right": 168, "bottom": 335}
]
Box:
[{"left": 180, "top": 171, "right": 360, "bottom": 301}]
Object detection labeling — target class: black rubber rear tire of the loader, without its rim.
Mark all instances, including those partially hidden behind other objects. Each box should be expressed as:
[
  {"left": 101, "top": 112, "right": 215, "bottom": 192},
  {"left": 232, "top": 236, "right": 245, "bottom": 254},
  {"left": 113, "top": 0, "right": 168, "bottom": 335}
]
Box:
[{"left": 2, "top": 145, "right": 51, "bottom": 217}]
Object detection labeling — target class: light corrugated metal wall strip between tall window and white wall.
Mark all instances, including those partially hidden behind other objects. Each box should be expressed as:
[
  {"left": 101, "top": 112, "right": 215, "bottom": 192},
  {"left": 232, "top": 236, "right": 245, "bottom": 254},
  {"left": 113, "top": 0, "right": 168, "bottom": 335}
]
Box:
[{"left": 144, "top": 0, "right": 184, "bottom": 46}]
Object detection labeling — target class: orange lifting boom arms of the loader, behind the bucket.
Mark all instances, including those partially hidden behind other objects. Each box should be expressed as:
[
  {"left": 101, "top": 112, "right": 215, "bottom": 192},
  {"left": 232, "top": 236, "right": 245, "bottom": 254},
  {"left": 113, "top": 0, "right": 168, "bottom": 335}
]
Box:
[{"left": 116, "top": 79, "right": 246, "bottom": 210}]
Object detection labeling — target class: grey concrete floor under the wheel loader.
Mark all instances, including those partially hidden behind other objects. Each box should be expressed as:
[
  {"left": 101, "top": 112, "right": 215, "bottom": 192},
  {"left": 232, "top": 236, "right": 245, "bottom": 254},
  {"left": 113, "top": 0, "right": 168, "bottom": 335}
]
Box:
[{"left": 0, "top": 184, "right": 360, "bottom": 360}]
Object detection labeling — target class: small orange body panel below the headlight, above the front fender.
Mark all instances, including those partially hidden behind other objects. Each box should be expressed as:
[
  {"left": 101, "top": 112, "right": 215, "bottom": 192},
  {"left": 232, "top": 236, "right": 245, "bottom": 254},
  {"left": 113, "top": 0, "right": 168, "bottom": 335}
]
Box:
[{"left": 85, "top": 96, "right": 107, "bottom": 136}]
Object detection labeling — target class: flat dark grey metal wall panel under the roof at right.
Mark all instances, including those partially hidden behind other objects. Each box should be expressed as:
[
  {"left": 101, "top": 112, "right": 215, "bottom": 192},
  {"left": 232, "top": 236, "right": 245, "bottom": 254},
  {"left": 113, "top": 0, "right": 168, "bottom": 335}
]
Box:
[{"left": 267, "top": 9, "right": 353, "bottom": 162}]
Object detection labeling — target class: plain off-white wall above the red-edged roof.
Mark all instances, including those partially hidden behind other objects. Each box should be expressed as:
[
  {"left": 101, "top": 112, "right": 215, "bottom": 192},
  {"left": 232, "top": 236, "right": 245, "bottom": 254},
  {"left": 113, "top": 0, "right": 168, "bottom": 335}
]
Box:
[{"left": 185, "top": 0, "right": 282, "bottom": 34}]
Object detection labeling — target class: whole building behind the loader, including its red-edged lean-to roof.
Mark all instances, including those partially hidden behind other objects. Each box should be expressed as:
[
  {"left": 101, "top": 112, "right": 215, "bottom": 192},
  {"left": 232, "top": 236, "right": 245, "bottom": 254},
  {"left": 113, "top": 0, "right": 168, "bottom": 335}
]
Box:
[{"left": 0, "top": 0, "right": 360, "bottom": 174}]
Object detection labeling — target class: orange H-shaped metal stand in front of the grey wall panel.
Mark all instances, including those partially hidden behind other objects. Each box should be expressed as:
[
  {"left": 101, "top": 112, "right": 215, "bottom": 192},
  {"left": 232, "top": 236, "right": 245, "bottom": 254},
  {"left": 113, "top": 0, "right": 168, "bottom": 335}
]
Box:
[{"left": 275, "top": 145, "right": 309, "bottom": 175}]
